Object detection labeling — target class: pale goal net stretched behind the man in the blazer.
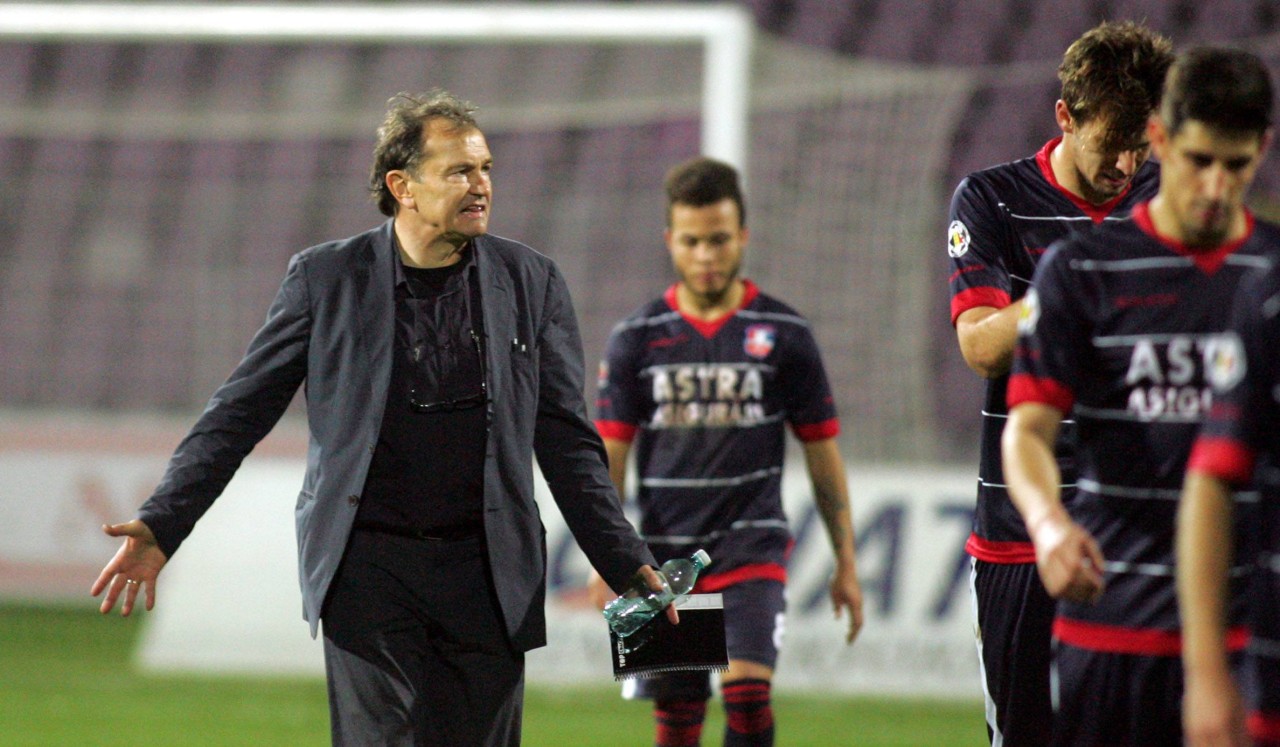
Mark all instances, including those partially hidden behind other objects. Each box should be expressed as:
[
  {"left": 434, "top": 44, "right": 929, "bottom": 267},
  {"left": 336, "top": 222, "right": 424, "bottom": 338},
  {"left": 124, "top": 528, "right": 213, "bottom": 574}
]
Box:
[{"left": 0, "top": 4, "right": 998, "bottom": 459}]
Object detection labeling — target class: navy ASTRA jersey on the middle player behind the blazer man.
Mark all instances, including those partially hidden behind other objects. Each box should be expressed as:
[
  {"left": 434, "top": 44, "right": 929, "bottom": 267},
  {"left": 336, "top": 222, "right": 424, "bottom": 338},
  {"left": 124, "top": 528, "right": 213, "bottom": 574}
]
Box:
[{"left": 596, "top": 281, "right": 840, "bottom": 591}]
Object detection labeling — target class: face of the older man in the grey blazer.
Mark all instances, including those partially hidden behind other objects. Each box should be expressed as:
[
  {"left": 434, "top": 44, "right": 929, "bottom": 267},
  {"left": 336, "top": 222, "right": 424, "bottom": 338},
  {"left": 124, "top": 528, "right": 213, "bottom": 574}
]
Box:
[{"left": 401, "top": 119, "right": 493, "bottom": 240}]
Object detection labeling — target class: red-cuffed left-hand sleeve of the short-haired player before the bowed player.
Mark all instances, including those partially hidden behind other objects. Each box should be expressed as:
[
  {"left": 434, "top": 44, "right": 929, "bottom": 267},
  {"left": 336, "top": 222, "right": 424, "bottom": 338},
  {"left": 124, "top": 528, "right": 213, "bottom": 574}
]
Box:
[{"left": 1007, "top": 243, "right": 1097, "bottom": 414}]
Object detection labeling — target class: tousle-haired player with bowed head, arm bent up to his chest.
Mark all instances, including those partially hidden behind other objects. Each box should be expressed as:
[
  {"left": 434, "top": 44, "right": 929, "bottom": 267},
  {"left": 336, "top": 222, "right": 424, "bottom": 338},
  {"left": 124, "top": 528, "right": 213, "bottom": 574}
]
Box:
[{"left": 947, "top": 23, "right": 1172, "bottom": 747}]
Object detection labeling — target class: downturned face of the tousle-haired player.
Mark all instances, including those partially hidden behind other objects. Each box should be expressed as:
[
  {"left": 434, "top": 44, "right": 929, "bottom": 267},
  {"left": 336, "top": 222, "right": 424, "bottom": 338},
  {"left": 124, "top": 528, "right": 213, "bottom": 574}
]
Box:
[{"left": 1062, "top": 113, "right": 1151, "bottom": 205}]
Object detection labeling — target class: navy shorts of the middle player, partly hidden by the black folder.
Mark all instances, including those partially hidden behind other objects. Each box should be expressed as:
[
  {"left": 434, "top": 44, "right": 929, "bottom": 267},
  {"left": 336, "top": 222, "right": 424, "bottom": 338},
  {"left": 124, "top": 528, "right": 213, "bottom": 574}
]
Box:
[{"left": 622, "top": 579, "right": 787, "bottom": 700}]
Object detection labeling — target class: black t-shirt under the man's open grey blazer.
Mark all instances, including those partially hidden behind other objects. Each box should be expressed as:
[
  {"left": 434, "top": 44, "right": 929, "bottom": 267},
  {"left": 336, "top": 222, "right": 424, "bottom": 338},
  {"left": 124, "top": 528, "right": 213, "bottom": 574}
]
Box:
[{"left": 356, "top": 253, "right": 488, "bottom": 535}]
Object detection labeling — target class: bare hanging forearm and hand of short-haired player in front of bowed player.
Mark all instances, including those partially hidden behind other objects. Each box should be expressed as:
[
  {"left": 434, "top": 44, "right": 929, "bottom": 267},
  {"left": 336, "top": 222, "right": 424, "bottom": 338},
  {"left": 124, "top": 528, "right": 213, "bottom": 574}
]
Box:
[{"left": 1001, "top": 402, "right": 1103, "bottom": 601}]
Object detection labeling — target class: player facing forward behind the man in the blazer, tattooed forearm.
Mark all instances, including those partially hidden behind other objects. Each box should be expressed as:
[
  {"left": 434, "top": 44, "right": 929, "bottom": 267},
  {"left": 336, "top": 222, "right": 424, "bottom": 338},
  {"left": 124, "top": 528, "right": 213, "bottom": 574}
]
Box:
[{"left": 593, "top": 159, "right": 863, "bottom": 747}]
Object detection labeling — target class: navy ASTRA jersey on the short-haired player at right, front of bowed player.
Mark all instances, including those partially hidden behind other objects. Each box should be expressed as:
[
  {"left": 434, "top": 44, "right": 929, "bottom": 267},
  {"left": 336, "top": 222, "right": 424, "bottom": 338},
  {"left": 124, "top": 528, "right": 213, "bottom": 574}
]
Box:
[{"left": 1009, "top": 203, "right": 1280, "bottom": 656}]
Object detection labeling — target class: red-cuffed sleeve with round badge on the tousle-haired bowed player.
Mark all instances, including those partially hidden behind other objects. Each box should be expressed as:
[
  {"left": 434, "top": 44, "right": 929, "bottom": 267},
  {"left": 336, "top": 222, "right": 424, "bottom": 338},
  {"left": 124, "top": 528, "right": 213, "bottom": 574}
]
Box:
[{"left": 947, "top": 177, "right": 1014, "bottom": 325}]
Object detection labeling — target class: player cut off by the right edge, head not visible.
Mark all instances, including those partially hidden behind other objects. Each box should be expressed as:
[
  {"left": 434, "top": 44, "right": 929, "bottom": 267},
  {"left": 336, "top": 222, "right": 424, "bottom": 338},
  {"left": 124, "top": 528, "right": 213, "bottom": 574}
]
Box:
[{"left": 1178, "top": 258, "right": 1280, "bottom": 747}]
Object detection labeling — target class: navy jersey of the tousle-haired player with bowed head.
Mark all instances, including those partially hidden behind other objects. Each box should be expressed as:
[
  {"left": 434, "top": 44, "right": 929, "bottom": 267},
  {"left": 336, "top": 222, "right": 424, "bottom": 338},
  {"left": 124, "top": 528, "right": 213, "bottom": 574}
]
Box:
[{"left": 947, "top": 138, "right": 1160, "bottom": 563}]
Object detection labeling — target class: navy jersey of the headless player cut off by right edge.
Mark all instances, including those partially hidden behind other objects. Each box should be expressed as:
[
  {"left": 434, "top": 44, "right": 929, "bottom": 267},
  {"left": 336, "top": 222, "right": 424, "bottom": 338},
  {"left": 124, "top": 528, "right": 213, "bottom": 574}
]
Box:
[{"left": 1188, "top": 258, "right": 1280, "bottom": 741}]
